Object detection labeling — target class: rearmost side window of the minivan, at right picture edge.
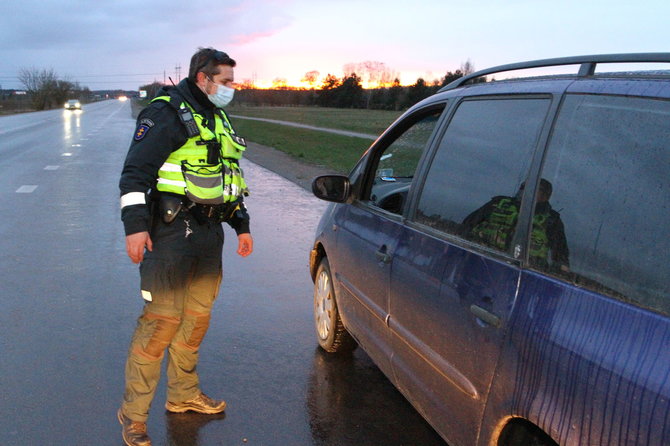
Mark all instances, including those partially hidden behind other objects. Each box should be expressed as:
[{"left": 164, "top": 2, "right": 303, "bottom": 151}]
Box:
[{"left": 530, "top": 95, "right": 670, "bottom": 314}]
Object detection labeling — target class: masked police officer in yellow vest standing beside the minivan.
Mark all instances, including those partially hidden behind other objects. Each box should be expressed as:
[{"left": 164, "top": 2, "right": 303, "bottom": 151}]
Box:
[{"left": 117, "top": 48, "right": 253, "bottom": 445}]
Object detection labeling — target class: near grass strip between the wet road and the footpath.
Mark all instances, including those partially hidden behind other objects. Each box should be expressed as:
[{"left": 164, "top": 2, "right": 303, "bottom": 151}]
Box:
[{"left": 231, "top": 118, "right": 372, "bottom": 173}]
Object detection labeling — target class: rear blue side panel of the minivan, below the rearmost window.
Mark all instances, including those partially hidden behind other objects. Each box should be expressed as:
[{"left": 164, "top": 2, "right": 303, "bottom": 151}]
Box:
[{"left": 480, "top": 272, "right": 670, "bottom": 446}]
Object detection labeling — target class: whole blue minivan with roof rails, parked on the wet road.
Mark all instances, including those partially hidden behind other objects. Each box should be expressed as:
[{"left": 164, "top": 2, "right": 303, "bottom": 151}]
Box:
[{"left": 310, "top": 53, "right": 670, "bottom": 446}]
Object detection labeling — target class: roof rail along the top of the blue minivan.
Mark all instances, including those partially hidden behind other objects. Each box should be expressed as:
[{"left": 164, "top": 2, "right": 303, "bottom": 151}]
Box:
[{"left": 439, "top": 53, "right": 670, "bottom": 92}]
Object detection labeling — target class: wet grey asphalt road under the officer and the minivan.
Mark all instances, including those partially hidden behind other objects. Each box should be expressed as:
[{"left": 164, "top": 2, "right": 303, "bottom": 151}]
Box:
[{"left": 0, "top": 101, "right": 444, "bottom": 446}]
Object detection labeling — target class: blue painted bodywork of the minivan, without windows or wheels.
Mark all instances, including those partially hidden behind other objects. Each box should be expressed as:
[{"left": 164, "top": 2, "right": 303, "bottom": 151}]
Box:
[{"left": 316, "top": 56, "right": 670, "bottom": 446}]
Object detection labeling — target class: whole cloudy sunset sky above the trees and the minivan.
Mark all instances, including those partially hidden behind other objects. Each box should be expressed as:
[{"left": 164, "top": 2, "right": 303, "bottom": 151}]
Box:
[{"left": 0, "top": 0, "right": 670, "bottom": 90}]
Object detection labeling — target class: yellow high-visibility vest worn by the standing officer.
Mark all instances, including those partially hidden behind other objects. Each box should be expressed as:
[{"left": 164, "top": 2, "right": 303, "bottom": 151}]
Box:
[{"left": 152, "top": 96, "right": 248, "bottom": 205}]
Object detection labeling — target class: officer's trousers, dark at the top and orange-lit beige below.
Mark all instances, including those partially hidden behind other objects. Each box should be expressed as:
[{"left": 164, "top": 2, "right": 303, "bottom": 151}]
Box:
[{"left": 121, "top": 211, "right": 223, "bottom": 422}]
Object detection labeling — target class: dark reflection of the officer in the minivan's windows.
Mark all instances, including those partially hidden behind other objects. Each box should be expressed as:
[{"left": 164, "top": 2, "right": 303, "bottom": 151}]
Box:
[{"left": 462, "top": 178, "right": 570, "bottom": 272}]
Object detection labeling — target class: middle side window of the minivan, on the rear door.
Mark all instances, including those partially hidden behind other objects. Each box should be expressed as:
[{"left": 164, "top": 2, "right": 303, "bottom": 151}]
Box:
[{"left": 415, "top": 98, "right": 550, "bottom": 252}]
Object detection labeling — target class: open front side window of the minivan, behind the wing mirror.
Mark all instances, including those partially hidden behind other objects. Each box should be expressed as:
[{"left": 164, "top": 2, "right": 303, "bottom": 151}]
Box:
[{"left": 369, "top": 104, "right": 444, "bottom": 214}]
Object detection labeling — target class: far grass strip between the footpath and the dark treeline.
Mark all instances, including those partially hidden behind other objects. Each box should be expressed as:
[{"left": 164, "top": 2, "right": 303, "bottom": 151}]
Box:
[{"left": 226, "top": 105, "right": 402, "bottom": 135}]
